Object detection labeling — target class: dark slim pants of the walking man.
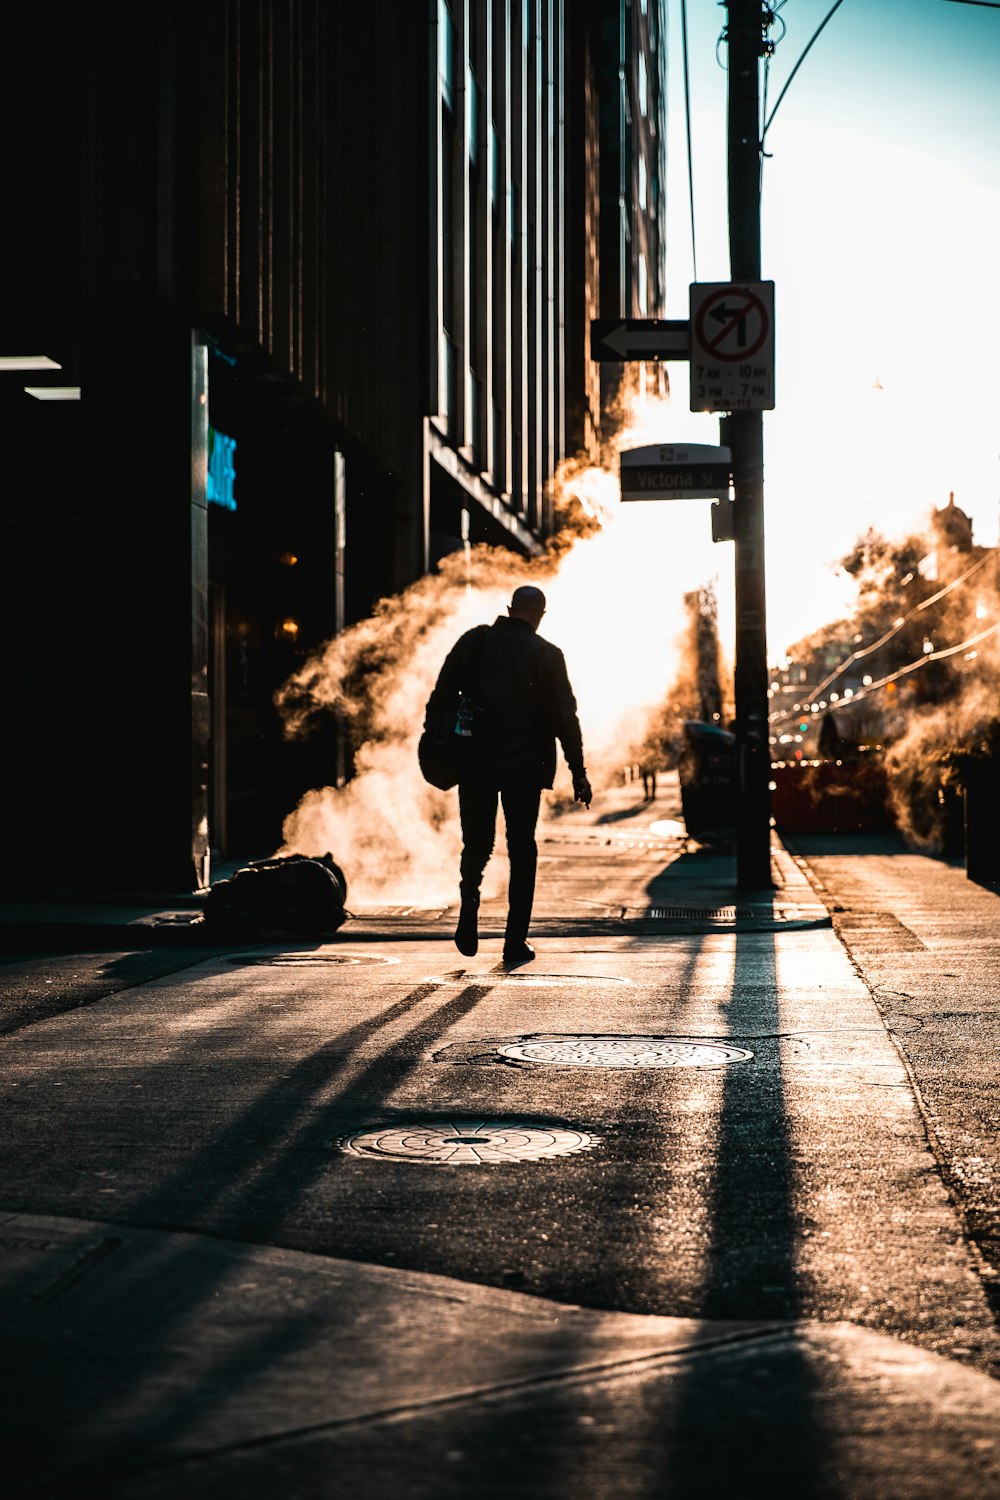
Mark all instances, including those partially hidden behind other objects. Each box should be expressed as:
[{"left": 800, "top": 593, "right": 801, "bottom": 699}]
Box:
[{"left": 459, "top": 773, "right": 541, "bottom": 947}]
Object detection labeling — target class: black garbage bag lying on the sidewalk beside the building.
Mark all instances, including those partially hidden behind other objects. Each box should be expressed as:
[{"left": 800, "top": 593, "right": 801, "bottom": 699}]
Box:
[{"left": 204, "top": 854, "right": 351, "bottom": 938}]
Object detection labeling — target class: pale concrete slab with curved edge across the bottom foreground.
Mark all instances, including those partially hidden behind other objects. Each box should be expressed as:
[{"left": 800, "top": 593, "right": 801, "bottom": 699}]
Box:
[{"left": 7, "top": 1215, "right": 1000, "bottom": 1500}]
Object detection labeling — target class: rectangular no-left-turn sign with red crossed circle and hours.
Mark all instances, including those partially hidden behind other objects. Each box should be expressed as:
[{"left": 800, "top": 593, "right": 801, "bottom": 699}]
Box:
[{"left": 690, "top": 282, "right": 774, "bottom": 411}]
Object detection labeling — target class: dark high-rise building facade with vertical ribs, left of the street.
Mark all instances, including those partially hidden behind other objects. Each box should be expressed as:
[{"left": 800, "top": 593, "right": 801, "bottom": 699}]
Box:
[{"left": 0, "top": 0, "right": 664, "bottom": 891}]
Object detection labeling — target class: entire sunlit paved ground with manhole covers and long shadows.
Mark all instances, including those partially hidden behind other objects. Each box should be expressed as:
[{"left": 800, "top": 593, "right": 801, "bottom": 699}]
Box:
[{"left": 0, "top": 795, "right": 1000, "bottom": 1500}]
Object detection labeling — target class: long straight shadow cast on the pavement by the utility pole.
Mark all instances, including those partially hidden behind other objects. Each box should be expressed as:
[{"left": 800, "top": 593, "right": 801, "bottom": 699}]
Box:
[{"left": 644, "top": 932, "right": 840, "bottom": 1500}]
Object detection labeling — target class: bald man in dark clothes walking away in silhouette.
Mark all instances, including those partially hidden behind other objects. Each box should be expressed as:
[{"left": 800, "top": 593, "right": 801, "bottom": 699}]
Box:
[{"left": 424, "top": 584, "right": 591, "bottom": 969}]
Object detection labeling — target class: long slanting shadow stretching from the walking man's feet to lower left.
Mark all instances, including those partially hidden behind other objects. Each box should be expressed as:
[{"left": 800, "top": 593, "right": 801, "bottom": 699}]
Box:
[{"left": 4, "top": 983, "right": 509, "bottom": 1496}]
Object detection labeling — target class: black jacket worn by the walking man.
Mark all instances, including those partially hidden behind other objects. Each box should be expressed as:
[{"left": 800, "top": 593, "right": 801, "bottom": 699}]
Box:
[{"left": 424, "top": 615, "right": 586, "bottom": 786}]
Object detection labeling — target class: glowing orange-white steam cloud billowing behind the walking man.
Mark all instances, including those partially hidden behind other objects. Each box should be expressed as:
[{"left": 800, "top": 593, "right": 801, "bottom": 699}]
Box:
[{"left": 276, "top": 401, "right": 731, "bottom": 909}]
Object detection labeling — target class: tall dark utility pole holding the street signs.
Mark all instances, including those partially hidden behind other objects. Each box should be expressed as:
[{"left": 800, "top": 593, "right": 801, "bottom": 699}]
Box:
[{"left": 723, "top": 0, "right": 774, "bottom": 890}]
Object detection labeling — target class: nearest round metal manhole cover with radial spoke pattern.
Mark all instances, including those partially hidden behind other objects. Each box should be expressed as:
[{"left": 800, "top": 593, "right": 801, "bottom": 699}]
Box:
[{"left": 339, "top": 1119, "right": 597, "bottom": 1167}]
